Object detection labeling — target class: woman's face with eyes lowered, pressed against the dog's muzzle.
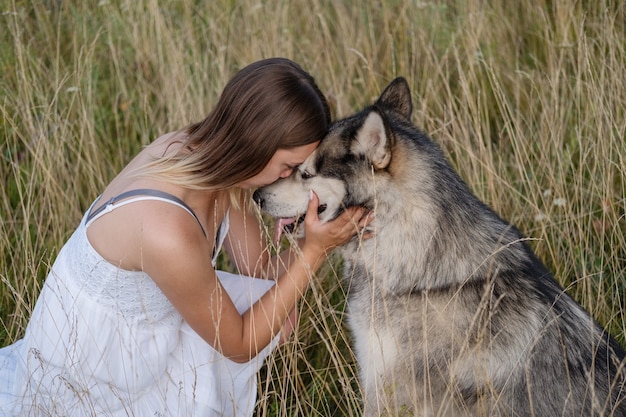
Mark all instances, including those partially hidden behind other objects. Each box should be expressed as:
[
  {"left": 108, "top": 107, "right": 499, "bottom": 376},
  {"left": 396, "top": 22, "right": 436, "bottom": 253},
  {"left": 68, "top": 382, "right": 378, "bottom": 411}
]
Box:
[{"left": 238, "top": 141, "right": 319, "bottom": 188}]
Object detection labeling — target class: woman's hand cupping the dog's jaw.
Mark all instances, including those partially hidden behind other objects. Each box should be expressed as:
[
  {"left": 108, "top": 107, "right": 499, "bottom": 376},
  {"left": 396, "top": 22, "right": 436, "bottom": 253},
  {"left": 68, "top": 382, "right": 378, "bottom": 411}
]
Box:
[{"left": 302, "top": 191, "right": 374, "bottom": 255}]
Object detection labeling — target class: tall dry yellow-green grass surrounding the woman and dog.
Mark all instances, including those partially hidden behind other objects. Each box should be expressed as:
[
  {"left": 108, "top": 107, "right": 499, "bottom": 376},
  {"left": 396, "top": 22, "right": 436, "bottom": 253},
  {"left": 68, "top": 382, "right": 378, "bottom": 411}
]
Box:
[{"left": 0, "top": 0, "right": 626, "bottom": 416}]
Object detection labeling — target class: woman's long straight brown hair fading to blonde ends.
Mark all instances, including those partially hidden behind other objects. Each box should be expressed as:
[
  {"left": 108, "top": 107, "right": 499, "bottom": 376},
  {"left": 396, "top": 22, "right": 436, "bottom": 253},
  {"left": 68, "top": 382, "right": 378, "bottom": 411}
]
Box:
[{"left": 141, "top": 58, "right": 330, "bottom": 201}]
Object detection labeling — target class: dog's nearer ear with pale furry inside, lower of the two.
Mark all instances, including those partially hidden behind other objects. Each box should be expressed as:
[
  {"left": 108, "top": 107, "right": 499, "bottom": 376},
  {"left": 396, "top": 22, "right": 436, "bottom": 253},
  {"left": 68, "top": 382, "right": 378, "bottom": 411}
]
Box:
[{"left": 351, "top": 110, "right": 392, "bottom": 169}]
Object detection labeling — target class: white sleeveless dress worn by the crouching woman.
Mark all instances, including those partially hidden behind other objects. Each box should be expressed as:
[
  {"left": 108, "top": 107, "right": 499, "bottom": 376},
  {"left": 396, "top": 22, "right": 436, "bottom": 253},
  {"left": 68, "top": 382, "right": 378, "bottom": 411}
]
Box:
[{"left": 0, "top": 193, "right": 278, "bottom": 417}]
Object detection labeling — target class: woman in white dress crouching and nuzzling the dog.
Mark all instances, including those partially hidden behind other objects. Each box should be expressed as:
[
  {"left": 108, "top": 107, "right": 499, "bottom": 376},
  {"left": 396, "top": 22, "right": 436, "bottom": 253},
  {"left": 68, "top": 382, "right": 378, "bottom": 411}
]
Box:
[{"left": 0, "top": 59, "right": 369, "bottom": 416}]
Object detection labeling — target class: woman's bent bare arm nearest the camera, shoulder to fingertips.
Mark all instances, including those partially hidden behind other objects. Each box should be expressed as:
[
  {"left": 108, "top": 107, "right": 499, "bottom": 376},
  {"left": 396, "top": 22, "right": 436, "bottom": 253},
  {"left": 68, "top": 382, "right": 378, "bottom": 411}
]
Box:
[{"left": 142, "top": 192, "right": 367, "bottom": 362}]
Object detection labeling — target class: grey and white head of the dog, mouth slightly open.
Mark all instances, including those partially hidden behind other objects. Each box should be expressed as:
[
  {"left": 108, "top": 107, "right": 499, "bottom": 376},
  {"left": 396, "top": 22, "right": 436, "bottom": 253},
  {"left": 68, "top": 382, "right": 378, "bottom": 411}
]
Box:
[{"left": 254, "top": 77, "right": 412, "bottom": 242}]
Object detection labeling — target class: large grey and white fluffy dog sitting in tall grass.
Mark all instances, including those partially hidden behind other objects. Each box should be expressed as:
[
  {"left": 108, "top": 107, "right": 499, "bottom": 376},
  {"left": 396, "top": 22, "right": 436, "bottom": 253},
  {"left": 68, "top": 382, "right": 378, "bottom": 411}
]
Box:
[{"left": 254, "top": 77, "right": 626, "bottom": 417}]
